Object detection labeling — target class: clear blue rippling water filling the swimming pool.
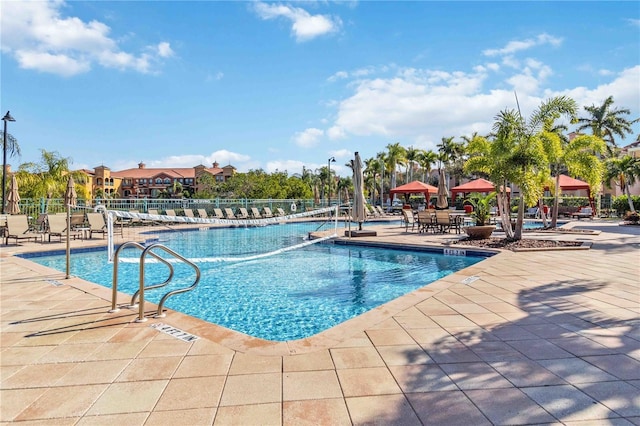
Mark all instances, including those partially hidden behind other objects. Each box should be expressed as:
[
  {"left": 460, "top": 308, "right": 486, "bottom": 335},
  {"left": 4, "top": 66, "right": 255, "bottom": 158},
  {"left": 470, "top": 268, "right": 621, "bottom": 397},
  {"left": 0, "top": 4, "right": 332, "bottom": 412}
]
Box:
[{"left": 22, "top": 223, "right": 483, "bottom": 341}]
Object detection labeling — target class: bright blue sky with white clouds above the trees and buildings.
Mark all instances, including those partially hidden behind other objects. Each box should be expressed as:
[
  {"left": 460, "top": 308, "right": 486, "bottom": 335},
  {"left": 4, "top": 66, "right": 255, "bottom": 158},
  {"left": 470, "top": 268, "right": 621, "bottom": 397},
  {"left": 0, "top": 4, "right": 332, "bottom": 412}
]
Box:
[{"left": 0, "top": 1, "right": 640, "bottom": 176}]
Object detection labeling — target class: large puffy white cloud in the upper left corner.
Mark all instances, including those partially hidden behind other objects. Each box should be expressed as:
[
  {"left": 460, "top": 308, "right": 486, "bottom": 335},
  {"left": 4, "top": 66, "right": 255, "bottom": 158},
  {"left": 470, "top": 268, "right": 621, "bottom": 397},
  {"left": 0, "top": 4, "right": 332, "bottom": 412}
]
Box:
[{"left": 0, "top": 0, "right": 174, "bottom": 77}]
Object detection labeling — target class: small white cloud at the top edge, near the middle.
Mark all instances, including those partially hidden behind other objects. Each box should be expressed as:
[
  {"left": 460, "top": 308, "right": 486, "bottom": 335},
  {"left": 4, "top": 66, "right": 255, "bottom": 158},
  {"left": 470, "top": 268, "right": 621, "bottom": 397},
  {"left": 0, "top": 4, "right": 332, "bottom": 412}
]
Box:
[{"left": 254, "top": 2, "right": 342, "bottom": 42}]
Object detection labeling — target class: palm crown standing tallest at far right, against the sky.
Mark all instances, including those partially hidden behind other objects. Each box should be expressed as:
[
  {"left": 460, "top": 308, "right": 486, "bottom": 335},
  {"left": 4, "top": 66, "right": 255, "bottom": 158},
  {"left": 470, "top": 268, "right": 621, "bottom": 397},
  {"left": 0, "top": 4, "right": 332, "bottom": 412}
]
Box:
[{"left": 576, "top": 96, "right": 638, "bottom": 155}]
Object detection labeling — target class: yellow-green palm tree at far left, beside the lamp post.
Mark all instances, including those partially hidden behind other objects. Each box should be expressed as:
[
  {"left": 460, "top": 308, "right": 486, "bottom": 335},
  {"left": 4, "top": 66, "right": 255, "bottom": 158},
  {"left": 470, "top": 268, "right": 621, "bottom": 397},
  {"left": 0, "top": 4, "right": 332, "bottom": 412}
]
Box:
[{"left": 16, "top": 149, "right": 86, "bottom": 211}]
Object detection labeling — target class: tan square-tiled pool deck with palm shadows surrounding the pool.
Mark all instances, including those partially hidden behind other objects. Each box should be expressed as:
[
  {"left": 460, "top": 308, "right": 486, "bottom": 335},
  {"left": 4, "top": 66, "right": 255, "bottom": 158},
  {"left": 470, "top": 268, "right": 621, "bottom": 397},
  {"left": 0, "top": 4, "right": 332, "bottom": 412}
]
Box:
[{"left": 0, "top": 221, "right": 640, "bottom": 425}]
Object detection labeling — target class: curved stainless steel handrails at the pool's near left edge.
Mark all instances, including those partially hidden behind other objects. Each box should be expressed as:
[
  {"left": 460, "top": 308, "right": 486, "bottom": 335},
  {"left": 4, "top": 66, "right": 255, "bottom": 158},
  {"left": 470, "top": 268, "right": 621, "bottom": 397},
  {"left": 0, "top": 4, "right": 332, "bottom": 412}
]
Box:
[{"left": 109, "top": 241, "right": 200, "bottom": 322}]
